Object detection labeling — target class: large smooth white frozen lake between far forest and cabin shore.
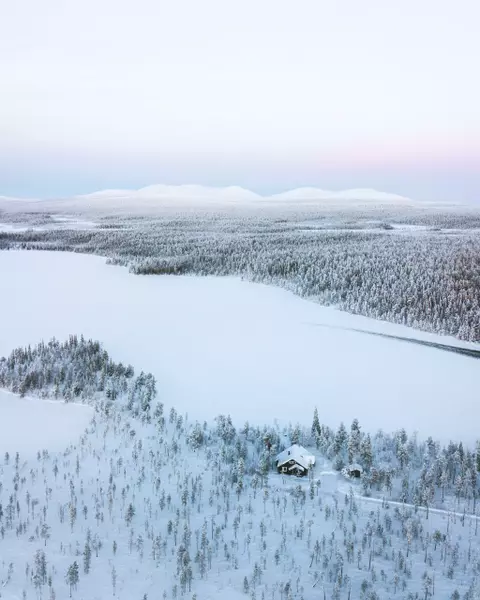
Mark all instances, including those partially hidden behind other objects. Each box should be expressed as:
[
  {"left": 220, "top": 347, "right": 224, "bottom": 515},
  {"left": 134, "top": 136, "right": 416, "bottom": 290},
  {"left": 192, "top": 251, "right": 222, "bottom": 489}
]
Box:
[{"left": 0, "top": 251, "right": 480, "bottom": 443}]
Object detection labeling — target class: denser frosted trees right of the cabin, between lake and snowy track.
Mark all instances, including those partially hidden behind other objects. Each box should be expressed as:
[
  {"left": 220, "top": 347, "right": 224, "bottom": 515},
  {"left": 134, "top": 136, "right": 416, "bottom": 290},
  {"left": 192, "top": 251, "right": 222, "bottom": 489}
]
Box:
[{"left": 308, "top": 409, "right": 480, "bottom": 513}]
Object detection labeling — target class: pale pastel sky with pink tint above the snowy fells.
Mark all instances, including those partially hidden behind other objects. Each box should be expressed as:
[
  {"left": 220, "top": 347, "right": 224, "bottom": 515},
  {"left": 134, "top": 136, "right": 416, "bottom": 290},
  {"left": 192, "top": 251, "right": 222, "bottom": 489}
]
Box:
[{"left": 0, "top": 0, "right": 480, "bottom": 201}]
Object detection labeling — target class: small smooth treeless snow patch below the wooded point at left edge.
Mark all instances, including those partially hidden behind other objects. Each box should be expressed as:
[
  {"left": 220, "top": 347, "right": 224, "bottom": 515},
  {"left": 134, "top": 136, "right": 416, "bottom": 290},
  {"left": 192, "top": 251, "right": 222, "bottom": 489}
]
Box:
[{"left": 0, "top": 390, "right": 94, "bottom": 459}]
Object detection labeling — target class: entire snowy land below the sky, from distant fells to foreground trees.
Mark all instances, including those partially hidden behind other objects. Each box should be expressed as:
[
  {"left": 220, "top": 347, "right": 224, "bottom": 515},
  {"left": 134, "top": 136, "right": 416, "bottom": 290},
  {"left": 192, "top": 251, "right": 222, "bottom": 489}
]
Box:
[{"left": 0, "top": 176, "right": 480, "bottom": 600}]
